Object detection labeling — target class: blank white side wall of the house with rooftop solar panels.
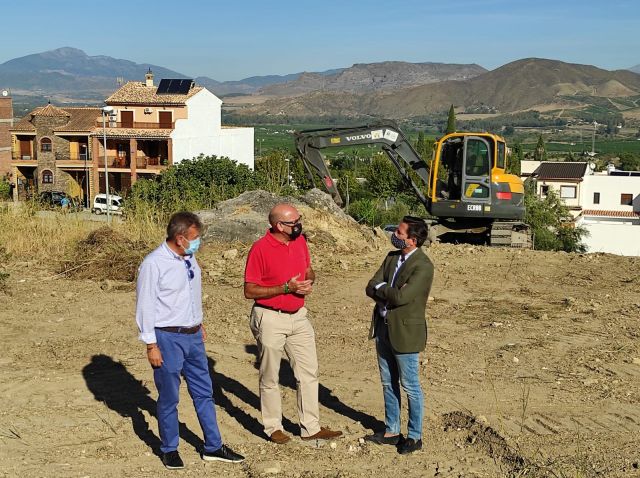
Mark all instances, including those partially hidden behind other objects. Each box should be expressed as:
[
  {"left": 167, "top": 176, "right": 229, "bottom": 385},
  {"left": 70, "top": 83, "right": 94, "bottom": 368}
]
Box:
[{"left": 171, "top": 89, "right": 254, "bottom": 169}]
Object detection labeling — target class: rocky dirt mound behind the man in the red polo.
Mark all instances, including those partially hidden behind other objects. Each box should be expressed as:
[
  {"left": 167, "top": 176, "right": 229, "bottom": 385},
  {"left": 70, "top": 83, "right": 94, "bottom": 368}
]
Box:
[{"left": 197, "top": 189, "right": 382, "bottom": 253}]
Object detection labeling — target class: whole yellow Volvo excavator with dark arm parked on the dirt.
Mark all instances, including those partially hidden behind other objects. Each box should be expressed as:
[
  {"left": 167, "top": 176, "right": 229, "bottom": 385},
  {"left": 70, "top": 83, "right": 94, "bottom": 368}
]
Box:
[{"left": 294, "top": 121, "right": 532, "bottom": 248}]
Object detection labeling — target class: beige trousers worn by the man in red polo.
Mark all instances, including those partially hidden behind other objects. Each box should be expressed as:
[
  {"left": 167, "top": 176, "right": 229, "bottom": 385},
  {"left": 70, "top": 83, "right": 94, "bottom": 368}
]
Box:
[{"left": 250, "top": 306, "right": 320, "bottom": 437}]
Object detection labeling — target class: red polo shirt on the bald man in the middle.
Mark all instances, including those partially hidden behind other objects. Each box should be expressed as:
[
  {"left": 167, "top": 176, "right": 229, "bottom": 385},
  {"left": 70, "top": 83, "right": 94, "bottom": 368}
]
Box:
[{"left": 244, "top": 231, "right": 311, "bottom": 312}]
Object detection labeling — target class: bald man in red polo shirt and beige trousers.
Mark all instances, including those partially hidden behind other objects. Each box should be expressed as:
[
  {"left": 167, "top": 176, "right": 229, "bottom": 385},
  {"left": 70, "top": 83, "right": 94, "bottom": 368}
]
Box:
[{"left": 244, "top": 204, "right": 342, "bottom": 444}]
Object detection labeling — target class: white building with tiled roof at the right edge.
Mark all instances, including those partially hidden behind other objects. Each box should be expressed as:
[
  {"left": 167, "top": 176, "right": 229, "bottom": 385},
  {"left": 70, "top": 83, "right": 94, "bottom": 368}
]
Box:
[{"left": 523, "top": 161, "right": 640, "bottom": 256}]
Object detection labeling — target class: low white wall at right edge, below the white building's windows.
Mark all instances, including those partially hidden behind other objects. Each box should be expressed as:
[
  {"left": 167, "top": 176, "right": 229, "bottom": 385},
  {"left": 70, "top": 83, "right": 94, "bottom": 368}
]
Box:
[{"left": 576, "top": 216, "right": 640, "bottom": 256}]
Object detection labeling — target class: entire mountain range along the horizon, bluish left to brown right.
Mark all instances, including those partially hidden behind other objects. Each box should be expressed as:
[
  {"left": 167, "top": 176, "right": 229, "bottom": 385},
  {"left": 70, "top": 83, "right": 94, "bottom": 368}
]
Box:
[{"left": 0, "top": 47, "right": 640, "bottom": 119}]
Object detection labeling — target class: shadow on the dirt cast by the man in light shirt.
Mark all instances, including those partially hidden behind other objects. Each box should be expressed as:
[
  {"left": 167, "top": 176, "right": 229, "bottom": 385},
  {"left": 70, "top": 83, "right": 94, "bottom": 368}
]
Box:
[{"left": 82, "top": 355, "right": 204, "bottom": 456}]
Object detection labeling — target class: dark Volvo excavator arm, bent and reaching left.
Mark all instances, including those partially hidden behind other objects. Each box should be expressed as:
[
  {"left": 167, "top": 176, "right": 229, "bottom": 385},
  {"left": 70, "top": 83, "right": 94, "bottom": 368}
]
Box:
[{"left": 295, "top": 121, "right": 429, "bottom": 210}]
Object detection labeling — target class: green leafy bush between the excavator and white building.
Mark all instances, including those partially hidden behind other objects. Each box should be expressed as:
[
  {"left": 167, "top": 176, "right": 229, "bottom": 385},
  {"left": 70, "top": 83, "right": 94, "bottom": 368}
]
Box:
[{"left": 524, "top": 181, "right": 588, "bottom": 252}]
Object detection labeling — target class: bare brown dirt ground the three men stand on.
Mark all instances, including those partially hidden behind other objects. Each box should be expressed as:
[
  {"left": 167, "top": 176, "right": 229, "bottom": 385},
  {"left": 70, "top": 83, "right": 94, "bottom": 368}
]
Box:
[{"left": 0, "top": 244, "right": 640, "bottom": 478}]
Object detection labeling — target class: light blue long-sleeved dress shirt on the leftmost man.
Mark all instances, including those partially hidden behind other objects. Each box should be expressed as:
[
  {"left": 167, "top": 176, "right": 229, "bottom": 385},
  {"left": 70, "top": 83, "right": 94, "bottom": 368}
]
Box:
[{"left": 136, "top": 242, "right": 202, "bottom": 344}]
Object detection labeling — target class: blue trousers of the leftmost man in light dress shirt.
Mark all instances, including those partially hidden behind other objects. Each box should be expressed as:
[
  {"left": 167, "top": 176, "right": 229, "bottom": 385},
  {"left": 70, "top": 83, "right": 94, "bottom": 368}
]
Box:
[{"left": 153, "top": 329, "right": 222, "bottom": 453}]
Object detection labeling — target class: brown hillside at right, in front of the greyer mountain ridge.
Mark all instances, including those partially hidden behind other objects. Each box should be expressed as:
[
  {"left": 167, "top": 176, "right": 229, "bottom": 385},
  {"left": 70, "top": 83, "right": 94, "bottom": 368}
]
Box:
[{"left": 236, "top": 58, "right": 640, "bottom": 118}]
